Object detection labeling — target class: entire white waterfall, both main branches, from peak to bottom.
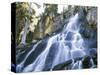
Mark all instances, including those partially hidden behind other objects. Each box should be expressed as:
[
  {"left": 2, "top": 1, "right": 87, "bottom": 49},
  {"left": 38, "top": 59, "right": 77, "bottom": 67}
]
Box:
[{"left": 16, "top": 13, "right": 85, "bottom": 72}]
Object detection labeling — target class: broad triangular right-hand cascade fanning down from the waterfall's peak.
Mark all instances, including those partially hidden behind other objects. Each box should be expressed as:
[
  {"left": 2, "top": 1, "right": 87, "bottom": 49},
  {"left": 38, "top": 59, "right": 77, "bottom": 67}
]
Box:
[{"left": 52, "top": 14, "right": 85, "bottom": 67}]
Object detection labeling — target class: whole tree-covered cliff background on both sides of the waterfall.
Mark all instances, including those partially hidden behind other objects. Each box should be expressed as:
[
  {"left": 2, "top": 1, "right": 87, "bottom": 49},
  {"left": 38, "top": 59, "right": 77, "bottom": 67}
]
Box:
[{"left": 16, "top": 3, "right": 97, "bottom": 44}]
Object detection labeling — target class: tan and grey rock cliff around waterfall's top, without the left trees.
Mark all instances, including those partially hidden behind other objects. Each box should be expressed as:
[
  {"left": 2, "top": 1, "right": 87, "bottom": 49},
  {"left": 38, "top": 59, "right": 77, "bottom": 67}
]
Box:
[{"left": 34, "top": 6, "right": 97, "bottom": 41}]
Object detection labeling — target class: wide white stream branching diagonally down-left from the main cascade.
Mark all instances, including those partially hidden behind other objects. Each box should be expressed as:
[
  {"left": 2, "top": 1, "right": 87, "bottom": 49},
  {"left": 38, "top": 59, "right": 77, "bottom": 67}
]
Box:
[{"left": 23, "top": 35, "right": 57, "bottom": 72}]
